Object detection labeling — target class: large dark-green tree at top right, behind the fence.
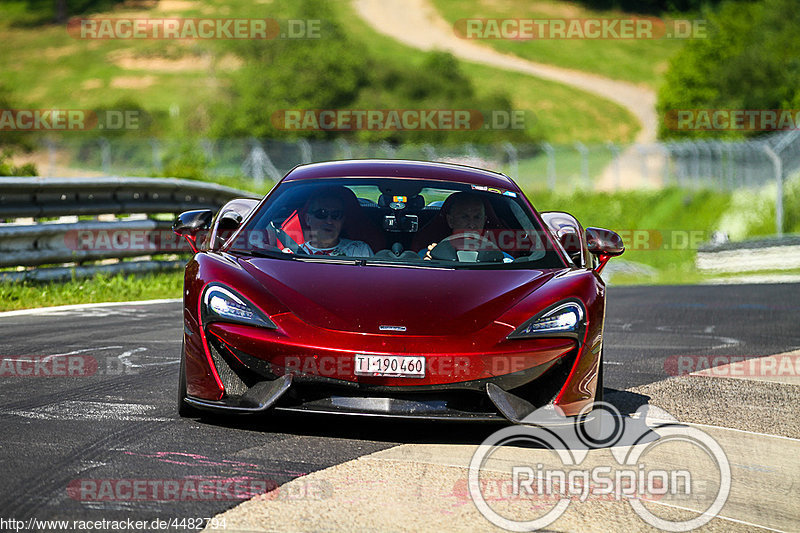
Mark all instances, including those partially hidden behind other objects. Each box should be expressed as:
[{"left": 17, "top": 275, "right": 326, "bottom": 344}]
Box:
[{"left": 658, "top": 0, "right": 800, "bottom": 138}]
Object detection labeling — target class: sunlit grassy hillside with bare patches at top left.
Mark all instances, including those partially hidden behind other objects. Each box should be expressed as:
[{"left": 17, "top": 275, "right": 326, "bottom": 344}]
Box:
[{"left": 0, "top": 0, "right": 296, "bottom": 112}]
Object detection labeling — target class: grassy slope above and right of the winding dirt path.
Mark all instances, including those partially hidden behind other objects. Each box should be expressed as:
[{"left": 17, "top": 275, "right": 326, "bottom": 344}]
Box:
[{"left": 432, "top": 0, "right": 684, "bottom": 89}]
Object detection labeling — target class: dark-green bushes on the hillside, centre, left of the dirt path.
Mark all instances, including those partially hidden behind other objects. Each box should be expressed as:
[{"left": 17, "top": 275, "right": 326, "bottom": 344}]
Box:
[{"left": 212, "top": 0, "right": 533, "bottom": 143}]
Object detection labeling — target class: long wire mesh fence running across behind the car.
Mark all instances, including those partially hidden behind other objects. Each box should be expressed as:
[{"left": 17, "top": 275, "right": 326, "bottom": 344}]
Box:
[{"left": 21, "top": 131, "right": 800, "bottom": 234}]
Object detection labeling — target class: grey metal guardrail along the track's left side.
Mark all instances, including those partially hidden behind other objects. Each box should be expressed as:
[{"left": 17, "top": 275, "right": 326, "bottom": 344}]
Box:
[{"left": 0, "top": 177, "right": 254, "bottom": 280}]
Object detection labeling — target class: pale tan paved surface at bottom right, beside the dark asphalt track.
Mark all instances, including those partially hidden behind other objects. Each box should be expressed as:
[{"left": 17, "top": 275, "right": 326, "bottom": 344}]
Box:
[{"left": 207, "top": 376, "right": 800, "bottom": 532}]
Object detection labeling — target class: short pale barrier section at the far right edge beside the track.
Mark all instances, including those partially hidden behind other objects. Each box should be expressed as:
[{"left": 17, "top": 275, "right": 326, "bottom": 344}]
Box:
[{"left": 695, "top": 235, "right": 800, "bottom": 273}]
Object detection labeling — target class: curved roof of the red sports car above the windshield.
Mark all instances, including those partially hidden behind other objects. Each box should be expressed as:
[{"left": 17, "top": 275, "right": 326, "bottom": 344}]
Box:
[{"left": 283, "top": 159, "right": 519, "bottom": 191}]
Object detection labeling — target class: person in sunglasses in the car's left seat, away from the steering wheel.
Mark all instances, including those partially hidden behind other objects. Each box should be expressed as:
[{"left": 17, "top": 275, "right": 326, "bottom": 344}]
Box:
[{"left": 300, "top": 191, "right": 373, "bottom": 257}]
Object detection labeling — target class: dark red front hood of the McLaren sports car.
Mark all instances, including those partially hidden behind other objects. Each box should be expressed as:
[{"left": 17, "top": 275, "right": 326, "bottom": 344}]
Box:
[{"left": 240, "top": 258, "right": 552, "bottom": 335}]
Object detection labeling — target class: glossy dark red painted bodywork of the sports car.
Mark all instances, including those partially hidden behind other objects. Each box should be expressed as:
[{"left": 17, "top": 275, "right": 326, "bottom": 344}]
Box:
[{"left": 184, "top": 161, "right": 605, "bottom": 415}]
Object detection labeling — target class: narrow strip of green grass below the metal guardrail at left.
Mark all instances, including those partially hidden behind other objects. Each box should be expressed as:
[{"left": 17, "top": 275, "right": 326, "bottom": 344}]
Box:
[{"left": 0, "top": 271, "right": 183, "bottom": 311}]
